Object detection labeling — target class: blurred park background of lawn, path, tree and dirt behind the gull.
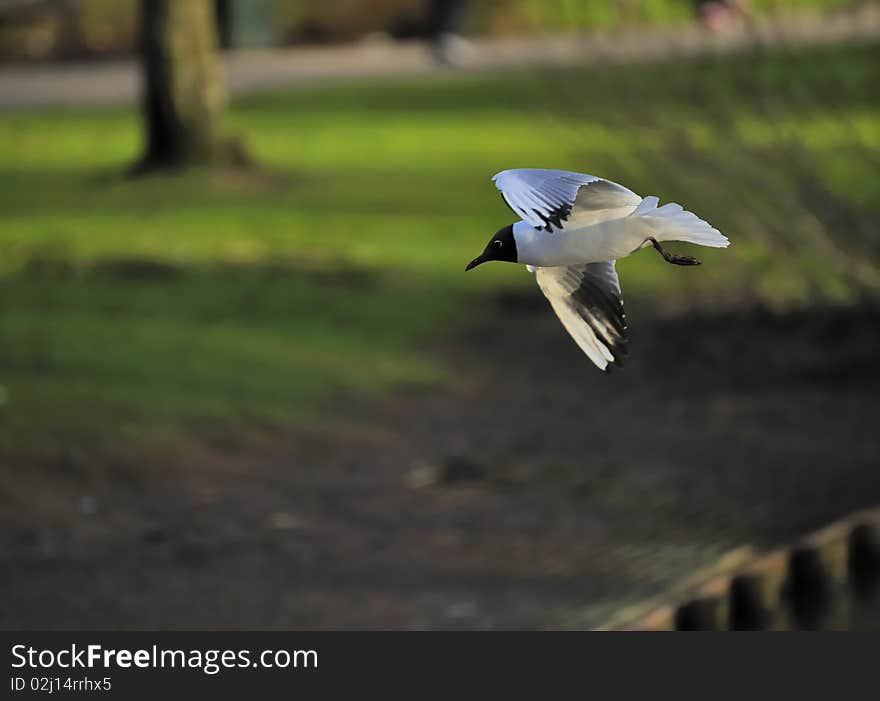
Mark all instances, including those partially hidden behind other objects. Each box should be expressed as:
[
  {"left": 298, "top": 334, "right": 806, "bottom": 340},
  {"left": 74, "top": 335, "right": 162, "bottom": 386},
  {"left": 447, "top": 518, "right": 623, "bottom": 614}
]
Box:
[{"left": 0, "top": 0, "right": 880, "bottom": 629}]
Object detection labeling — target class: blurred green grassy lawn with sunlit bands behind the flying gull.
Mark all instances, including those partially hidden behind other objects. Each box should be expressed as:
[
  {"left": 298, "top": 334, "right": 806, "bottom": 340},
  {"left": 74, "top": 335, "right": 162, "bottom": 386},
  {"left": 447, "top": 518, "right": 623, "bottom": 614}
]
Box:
[{"left": 0, "top": 43, "right": 880, "bottom": 456}]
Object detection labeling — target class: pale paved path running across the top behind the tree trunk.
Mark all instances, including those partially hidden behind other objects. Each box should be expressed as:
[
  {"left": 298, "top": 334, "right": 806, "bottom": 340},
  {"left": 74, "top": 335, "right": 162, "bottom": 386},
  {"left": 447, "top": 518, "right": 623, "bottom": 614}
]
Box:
[{"left": 0, "top": 7, "right": 880, "bottom": 109}]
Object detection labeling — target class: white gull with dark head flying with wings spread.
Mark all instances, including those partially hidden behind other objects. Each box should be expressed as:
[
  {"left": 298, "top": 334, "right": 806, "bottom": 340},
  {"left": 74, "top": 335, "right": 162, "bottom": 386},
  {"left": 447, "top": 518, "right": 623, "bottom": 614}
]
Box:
[{"left": 465, "top": 168, "right": 729, "bottom": 370}]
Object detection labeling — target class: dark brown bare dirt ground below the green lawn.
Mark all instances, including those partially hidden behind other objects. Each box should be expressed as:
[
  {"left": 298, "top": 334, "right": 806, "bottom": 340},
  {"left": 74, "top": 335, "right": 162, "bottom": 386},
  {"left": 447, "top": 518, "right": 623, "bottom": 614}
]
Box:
[{"left": 0, "top": 294, "right": 880, "bottom": 629}]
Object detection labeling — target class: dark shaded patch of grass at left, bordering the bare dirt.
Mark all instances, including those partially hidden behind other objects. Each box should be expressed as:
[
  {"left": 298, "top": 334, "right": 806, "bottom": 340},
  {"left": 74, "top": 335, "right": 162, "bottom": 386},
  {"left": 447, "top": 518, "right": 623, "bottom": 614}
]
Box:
[{"left": 0, "top": 256, "right": 461, "bottom": 456}]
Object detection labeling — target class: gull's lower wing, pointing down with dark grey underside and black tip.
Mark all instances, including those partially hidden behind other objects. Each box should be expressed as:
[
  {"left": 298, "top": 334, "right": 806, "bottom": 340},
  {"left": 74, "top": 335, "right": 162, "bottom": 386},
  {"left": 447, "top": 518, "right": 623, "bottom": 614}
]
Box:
[{"left": 534, "top": 260, "right": 627, "bottom": 370}]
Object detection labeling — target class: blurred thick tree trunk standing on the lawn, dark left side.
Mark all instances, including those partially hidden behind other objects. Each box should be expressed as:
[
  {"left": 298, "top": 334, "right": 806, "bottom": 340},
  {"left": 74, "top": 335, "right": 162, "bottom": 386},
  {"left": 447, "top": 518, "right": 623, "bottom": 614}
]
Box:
[{"left": 135, "top": 0, "right": 245, "bottom": 171}]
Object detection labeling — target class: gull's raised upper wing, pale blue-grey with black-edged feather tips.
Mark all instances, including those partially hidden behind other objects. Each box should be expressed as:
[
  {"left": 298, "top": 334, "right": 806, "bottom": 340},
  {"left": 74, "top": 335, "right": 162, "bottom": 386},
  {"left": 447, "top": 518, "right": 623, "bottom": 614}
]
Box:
[{"left": 492, "top": 168, "right": 642, "bottom": 232}]
